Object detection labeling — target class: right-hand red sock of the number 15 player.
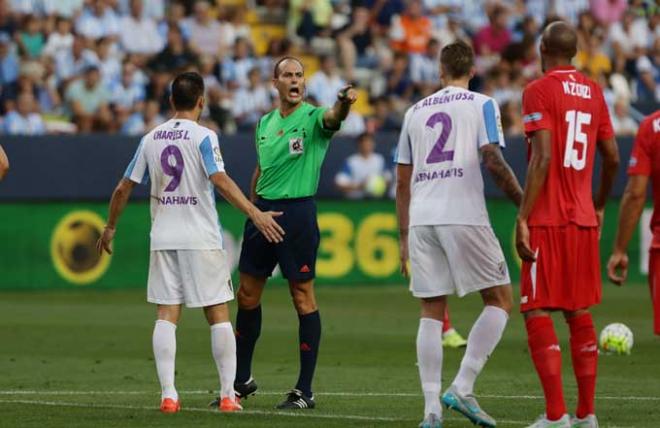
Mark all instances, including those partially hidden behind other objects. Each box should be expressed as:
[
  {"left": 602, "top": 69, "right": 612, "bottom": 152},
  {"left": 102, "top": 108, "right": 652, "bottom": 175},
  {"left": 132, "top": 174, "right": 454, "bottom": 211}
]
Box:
[{"left": 568, "top": 313, "right": 598, "bottom": 418}]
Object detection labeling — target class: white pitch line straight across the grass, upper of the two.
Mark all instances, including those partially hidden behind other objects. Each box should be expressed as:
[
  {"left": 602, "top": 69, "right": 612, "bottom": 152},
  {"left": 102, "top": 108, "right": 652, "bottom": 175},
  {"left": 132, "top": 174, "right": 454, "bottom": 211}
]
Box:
[{"left": 0, "top": 389, "right": 660, "bottom": 401}]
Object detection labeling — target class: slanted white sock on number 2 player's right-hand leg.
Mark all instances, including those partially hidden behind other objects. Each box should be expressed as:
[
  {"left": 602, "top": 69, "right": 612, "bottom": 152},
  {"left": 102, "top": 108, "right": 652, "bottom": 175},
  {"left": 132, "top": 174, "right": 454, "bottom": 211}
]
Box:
[{"left": 453, "top": 306, "right": 509, "bottom": 395}]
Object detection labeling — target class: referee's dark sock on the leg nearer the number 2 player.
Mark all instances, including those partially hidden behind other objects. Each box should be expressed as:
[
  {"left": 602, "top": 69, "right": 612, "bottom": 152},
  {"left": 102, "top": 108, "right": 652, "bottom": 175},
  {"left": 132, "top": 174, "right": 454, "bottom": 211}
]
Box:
[{"left": 296, "top": 310, "right": 321, "bottom": 397}]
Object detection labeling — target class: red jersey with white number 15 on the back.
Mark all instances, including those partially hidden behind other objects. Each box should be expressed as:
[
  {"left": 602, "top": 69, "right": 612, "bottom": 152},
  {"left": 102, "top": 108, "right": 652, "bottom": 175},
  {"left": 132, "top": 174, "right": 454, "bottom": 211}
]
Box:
[{"left": 523, "top": 66, "right": 614, "bottom": 226}]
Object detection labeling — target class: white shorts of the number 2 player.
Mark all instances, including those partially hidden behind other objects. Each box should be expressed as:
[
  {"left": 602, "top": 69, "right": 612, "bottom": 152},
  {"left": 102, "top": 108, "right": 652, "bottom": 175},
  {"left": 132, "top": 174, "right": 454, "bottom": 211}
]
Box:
[{"left": 408, "top": 225, "right": 511, "bottom": 298}]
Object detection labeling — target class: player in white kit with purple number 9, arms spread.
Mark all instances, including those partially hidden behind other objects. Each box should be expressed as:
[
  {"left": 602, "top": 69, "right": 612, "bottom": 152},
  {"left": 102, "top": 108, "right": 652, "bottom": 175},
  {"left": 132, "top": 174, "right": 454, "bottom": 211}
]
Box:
[{"left": 98, "top": 73, "right": 284, "bottom": 413}]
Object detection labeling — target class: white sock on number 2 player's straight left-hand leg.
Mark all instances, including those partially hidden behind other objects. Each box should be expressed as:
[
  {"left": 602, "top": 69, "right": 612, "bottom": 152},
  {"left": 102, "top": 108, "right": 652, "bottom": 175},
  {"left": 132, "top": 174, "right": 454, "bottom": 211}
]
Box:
[{"left": 417, "top": 318, "right": 442, "bottom": 417}]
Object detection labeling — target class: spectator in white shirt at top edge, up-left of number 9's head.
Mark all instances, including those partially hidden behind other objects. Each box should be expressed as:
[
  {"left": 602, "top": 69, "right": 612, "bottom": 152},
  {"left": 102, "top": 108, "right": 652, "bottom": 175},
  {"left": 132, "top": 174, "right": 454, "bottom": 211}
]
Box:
[{"left": 186, "top": 1, "right": 227, "bottom": 57}]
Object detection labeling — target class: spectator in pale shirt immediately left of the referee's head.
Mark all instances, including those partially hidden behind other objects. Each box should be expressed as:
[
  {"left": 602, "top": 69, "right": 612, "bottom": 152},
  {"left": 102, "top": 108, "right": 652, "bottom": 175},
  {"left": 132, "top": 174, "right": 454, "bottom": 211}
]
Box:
[{"left": 232, "top": 67, "right": 272, "bottom": 130}]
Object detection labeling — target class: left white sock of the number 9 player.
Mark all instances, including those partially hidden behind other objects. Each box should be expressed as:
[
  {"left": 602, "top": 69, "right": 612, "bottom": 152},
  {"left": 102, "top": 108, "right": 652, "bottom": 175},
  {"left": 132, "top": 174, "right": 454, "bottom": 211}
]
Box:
[{"left": 152, "top": 320, "right": 179, "bottom": 400}]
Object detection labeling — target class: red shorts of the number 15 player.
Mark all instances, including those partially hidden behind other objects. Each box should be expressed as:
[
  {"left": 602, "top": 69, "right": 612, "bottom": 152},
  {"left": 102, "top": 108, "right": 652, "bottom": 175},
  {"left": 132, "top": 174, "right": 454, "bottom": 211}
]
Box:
[{"left": 520, "top": 224, "right": 602, "bottom": 312}]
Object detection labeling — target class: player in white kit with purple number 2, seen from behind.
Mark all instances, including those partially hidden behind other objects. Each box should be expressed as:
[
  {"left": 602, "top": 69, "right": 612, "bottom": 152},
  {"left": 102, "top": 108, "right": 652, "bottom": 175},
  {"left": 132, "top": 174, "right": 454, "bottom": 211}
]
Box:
[{"left": 396, "top": 42, "right": 522, "bottom": 428}]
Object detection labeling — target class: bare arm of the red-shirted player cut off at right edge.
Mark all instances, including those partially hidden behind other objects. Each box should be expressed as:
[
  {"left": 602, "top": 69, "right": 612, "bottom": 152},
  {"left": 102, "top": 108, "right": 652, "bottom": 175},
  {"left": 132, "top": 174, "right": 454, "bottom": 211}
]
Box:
[{"left": 607, "top": 175, "right": 649, "bottom": 285}]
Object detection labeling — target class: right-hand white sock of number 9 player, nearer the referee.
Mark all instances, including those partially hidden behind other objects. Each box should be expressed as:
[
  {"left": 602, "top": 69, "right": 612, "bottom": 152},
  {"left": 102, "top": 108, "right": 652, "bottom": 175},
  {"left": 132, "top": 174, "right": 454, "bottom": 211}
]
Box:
[{"left": 211, "top": 322, "right": 236, "bottom": 400}]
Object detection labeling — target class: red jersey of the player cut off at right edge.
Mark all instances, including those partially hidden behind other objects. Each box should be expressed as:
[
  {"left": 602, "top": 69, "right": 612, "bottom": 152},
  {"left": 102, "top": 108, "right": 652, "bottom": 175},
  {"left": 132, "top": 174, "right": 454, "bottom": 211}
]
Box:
[{"left": 628, "top": 110, "right": 660, "bottom": 248}]
